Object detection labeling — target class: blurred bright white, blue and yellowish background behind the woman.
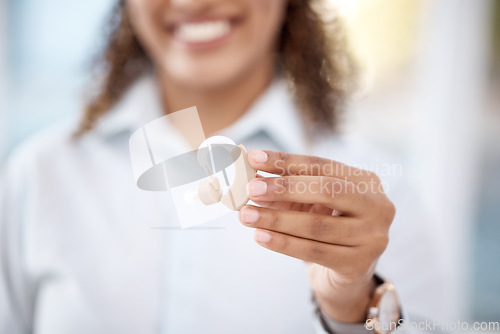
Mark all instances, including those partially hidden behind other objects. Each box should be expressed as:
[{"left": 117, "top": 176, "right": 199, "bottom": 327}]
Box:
[{"left": 0, "top": 0, "right": 500, "bottom": 321}]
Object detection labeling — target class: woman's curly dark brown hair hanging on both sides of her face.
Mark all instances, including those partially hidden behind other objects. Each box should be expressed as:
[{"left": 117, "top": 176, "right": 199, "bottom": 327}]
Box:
[{"left": 76, "top": 0, "right": 357, "bottom": 137}]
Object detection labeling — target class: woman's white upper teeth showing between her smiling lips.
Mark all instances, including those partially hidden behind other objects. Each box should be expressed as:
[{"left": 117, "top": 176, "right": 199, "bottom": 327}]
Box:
[{"left": 175, "top": 20, "right": 231, "bottom": 43}]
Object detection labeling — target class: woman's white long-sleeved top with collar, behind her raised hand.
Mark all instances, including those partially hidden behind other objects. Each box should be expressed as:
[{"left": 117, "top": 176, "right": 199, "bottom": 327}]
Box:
[{"left": 0, "top": 76, "right": 452, "bottom": 334}]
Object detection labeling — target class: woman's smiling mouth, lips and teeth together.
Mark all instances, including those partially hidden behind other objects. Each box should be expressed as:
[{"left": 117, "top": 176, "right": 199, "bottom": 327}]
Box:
[{"left": 169, "top": 18, "right": 239, "bottom": 47}]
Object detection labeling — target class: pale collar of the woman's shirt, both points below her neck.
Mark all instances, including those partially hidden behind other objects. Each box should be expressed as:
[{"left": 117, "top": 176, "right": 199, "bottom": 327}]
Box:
[{"left": 95, "top": 74, "right": 307, "bottom": 153}]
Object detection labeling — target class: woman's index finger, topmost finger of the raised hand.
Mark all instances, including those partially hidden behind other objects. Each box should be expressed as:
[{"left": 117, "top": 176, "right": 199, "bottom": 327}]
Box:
[{"left": 248, "top": 150, "right": 368, "bottom": 182}]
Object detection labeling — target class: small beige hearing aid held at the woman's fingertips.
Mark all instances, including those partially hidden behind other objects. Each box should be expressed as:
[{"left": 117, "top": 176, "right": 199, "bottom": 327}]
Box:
[{"left": 186, "top": 136, "right": 255, "bottom": 211}]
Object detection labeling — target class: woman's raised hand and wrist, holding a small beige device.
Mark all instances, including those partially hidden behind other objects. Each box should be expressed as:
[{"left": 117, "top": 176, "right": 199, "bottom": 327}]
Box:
[{"left": 239, "top": 150, "right": 395, "bottom": 322}]
